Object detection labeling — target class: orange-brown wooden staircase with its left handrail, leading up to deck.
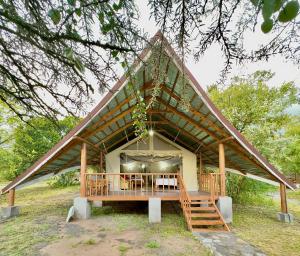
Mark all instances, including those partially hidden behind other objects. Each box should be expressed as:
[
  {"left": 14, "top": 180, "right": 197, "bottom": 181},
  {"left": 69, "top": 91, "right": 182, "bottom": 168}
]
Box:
[{"left": 178, "top": 175, "right": 230, "bottom": 232}]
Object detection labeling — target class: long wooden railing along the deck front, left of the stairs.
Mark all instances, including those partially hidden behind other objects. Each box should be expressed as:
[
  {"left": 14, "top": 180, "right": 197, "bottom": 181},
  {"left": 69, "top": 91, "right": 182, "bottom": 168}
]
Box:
[{"left": 85, "top": 173, "right": 179, "bottom": 196}]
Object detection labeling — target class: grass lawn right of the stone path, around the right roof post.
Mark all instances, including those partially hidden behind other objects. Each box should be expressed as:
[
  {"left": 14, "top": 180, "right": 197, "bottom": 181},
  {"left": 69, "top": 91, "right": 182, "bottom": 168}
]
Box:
[{"left": 232, "top": 192, "right": 300, "bottom": 256}]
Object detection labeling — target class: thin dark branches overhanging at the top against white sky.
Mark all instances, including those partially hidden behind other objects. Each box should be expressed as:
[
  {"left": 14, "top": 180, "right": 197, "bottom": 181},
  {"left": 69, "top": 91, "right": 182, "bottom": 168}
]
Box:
[{"left": 0, "top": 0, "right": 300, "bottom": 118}]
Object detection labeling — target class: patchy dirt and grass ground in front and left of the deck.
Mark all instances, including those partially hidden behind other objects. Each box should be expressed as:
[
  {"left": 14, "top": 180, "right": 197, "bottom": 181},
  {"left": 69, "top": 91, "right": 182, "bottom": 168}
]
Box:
[{"left": 0, "top": 185, "right": 210, "bottom": 256}]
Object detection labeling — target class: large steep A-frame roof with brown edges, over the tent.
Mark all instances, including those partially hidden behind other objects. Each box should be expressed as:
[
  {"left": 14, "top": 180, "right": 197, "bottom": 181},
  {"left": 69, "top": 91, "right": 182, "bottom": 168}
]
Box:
[{"left": 1, "top": 32, "right": 294, "bottom": 193}]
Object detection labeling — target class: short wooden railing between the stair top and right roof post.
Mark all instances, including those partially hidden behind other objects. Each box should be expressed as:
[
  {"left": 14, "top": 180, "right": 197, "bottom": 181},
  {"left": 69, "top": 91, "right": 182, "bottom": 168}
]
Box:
[{"left": 200, "top": 173, "right": 221, "bottom": 201}]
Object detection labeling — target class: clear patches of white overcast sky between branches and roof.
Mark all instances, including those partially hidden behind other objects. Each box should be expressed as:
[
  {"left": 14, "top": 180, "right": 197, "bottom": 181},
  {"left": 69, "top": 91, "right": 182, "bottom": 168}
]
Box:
[{"left": 88, "top": 0, "right": 300, "bottom": 114}]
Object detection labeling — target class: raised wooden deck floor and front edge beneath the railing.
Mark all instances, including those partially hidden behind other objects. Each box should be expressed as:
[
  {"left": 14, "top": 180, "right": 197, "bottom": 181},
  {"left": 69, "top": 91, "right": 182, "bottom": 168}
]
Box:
[{"left": 87, "top": 190, "right": 214, "bottom": 201}]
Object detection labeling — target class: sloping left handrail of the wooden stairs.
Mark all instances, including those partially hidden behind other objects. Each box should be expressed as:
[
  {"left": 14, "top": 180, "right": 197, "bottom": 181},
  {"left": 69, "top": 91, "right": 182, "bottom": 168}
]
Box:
[{"left": 178, "top": 175, "right": 192, "bottom": 230}]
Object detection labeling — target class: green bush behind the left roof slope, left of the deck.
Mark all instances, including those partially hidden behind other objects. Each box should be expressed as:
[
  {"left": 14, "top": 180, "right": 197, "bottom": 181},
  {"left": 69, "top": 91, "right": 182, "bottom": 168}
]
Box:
[{"left": 48, "top": 170, "right": 79, "bottom": 188}]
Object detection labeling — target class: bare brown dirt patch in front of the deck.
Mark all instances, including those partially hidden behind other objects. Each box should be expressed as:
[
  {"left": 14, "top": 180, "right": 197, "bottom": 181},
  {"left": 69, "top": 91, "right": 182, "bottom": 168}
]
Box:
[{"left": 41, "top": 216, "right": 207, "bottom": 256}]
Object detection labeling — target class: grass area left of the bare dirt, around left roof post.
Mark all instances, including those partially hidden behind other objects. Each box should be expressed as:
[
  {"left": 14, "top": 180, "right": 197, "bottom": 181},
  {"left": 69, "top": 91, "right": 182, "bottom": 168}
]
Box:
[{"left": 0, "top": 184, "right": 78, "bottom": 256}]
